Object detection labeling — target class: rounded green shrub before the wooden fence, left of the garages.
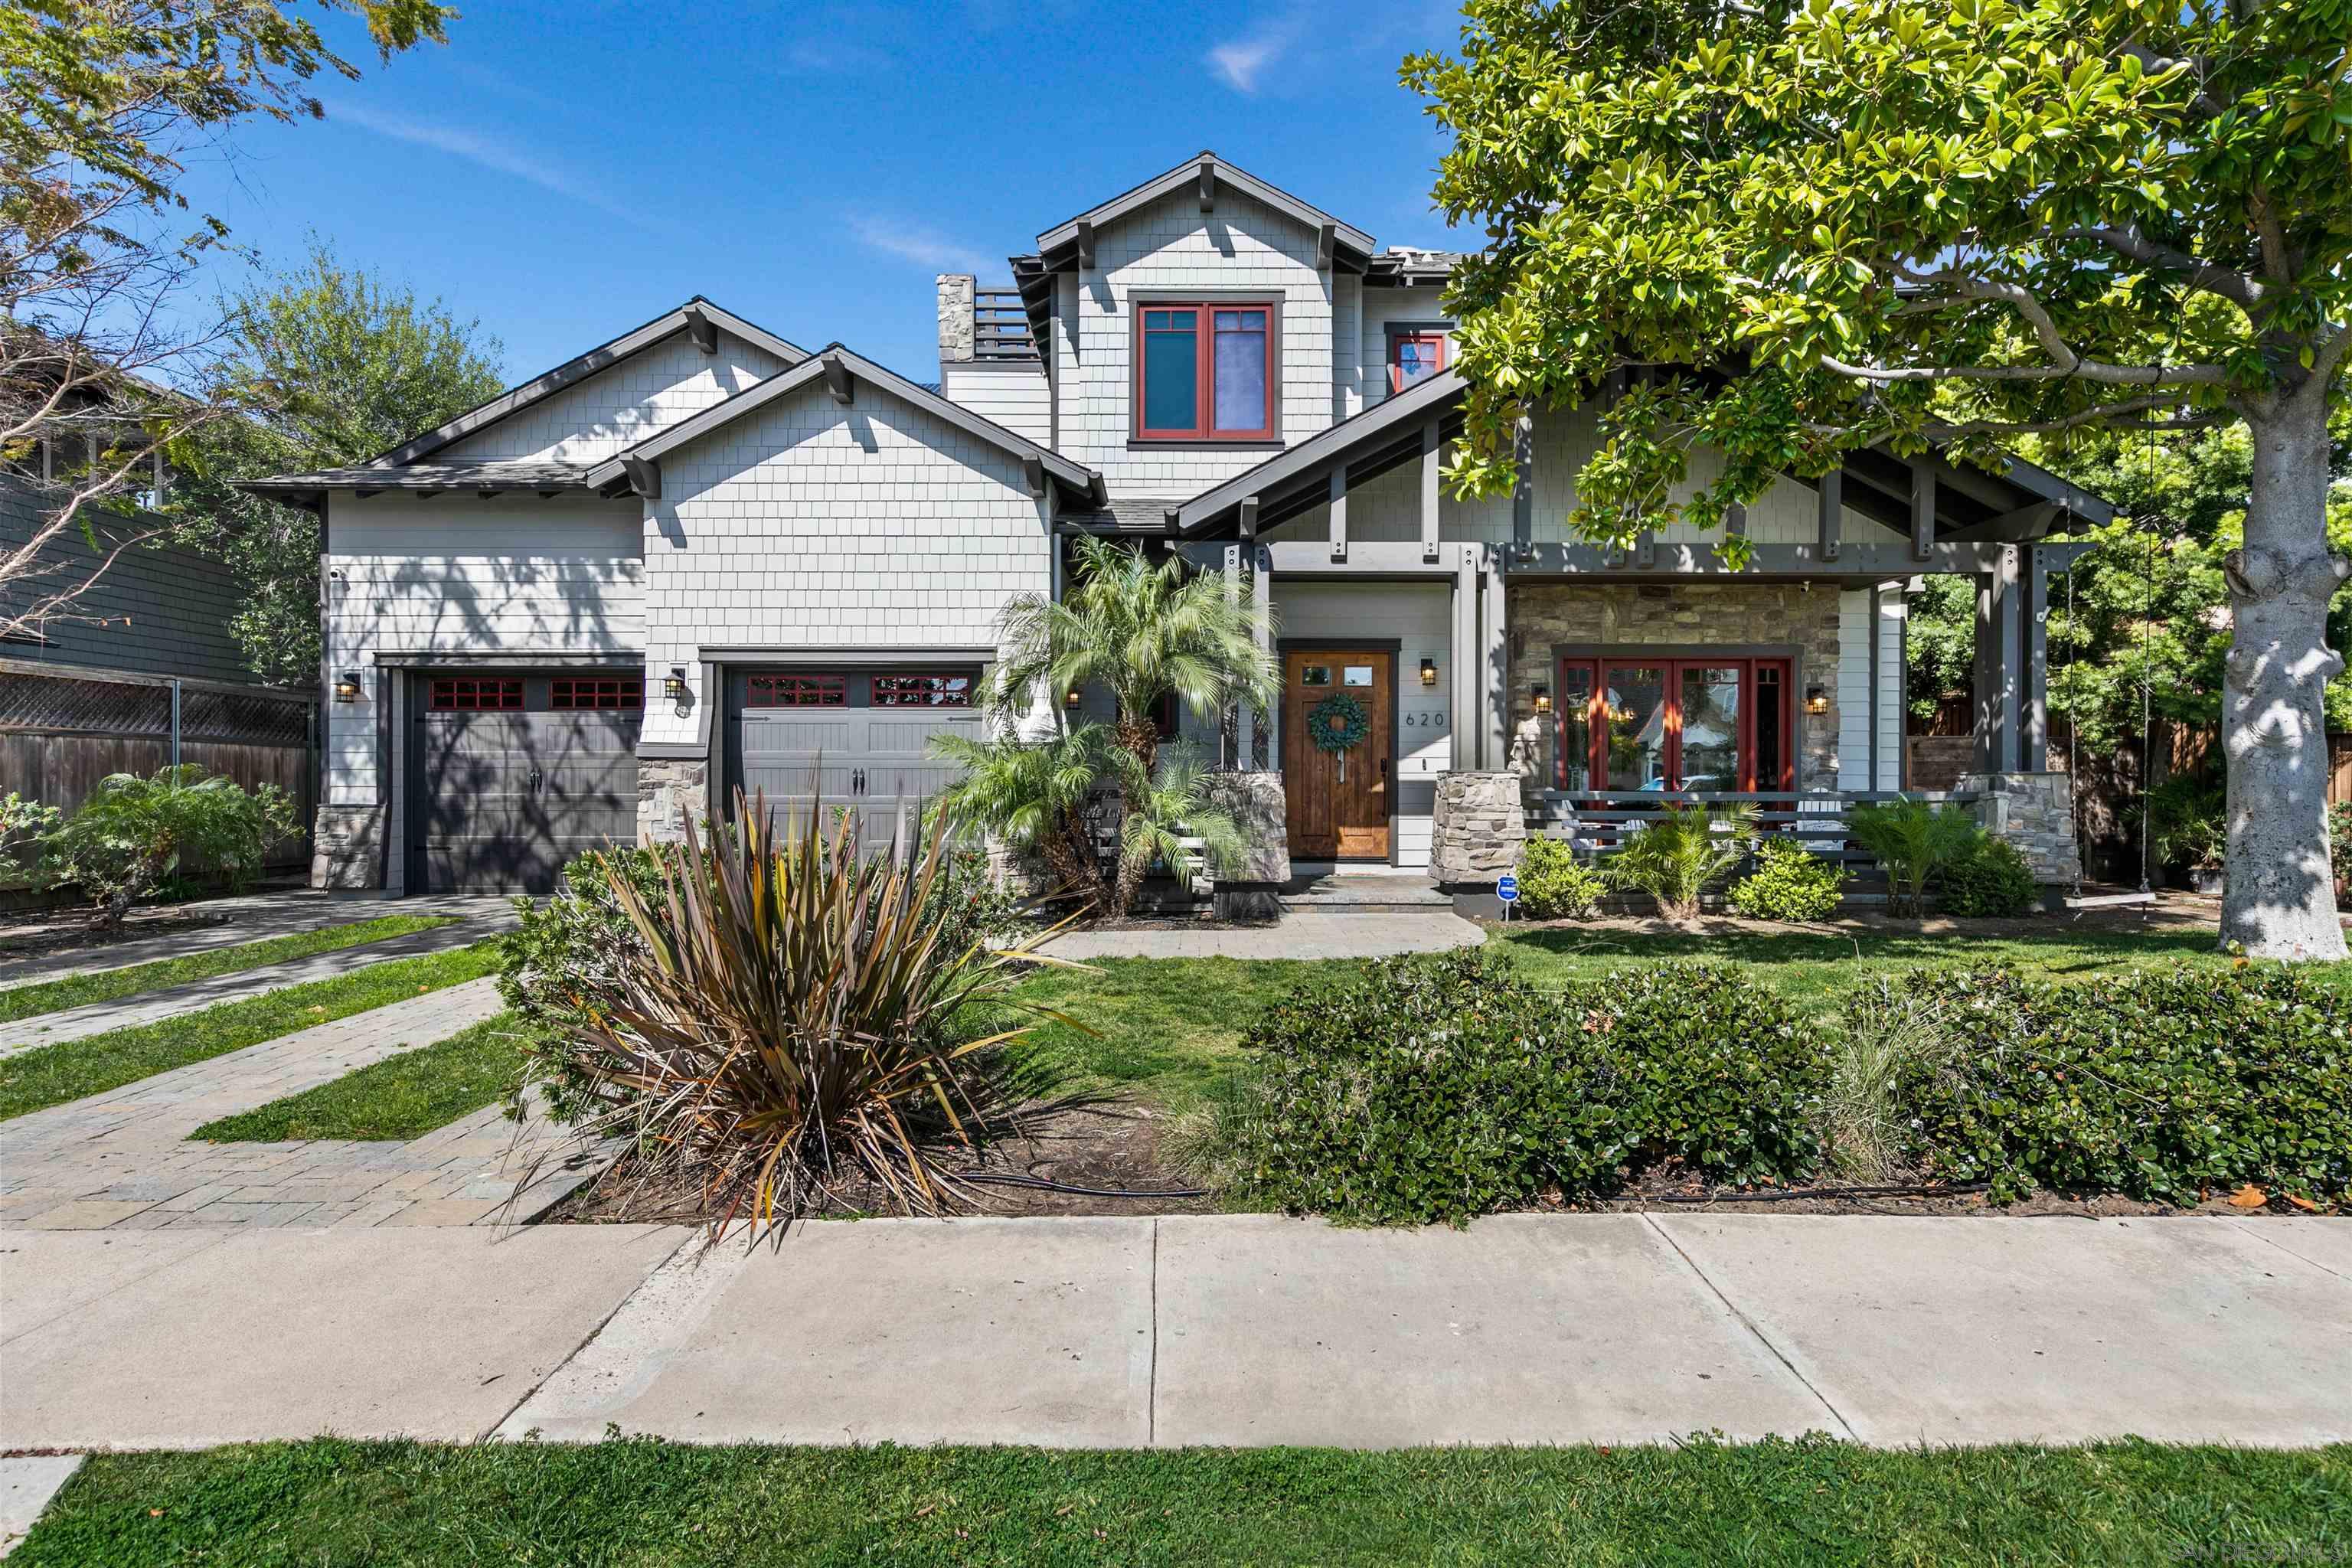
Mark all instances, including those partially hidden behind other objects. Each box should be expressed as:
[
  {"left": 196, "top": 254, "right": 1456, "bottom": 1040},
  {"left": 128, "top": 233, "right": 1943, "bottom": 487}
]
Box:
[{"left": 47, "top": 762, "right": 299, "bottom": 922}]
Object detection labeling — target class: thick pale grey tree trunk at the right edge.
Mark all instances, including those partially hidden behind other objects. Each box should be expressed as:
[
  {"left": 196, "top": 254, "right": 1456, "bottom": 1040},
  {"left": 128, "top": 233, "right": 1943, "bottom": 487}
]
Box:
[{"left": 2220, "top": 383, "right": 2352, "bottom": 959}]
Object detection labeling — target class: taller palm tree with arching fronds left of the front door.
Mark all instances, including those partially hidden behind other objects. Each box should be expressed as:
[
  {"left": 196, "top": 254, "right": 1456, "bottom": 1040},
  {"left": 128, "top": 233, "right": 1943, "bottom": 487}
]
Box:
[{"left": 992, "top": 538, "right": 1279, "bottom": 778}]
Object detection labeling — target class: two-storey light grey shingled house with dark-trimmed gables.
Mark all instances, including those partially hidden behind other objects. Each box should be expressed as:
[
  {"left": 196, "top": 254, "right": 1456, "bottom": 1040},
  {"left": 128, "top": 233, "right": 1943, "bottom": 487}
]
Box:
[{"left": 254, "top": 153, "right": 2110, "bottom": 891}]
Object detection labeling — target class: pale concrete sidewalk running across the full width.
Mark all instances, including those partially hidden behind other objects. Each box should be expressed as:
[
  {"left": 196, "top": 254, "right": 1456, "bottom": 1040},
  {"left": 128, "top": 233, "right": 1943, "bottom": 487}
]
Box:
[{"left": 0, "top": 1215, "right": 2352, "bottom": 1448}]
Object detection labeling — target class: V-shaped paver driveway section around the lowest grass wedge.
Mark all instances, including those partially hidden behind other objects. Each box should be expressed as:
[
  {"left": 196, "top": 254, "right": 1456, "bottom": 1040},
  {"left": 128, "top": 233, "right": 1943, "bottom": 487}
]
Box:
[{"left": 0, "top": 980, "right": 593, "bottom": 1230}]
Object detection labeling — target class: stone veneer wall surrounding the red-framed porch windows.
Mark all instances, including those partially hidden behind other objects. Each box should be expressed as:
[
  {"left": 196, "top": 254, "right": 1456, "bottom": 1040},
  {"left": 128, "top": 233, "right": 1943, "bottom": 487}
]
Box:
[{"left": 1508, "top": 580, "right": 1839, "bottom": 790}]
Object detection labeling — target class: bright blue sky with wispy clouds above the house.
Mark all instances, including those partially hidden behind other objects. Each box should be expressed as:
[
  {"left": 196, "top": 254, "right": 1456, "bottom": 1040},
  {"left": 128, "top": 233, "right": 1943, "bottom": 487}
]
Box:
[{"left": 188, "top": 0, "right": 1459, "bottom": 381}]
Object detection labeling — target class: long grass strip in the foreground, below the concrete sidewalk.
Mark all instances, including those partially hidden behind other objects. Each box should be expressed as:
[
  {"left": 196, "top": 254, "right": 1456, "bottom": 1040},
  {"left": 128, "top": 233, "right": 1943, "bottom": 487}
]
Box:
[{"left": 11, "top": 1439, "right": 2352, "bottom": 1568}]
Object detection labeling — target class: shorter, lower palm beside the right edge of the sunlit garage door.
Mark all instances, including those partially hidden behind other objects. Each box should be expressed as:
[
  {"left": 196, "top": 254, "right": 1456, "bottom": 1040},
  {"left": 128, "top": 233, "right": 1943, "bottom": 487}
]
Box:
[{"left": 932, "top": 724, "right": 1117, "bottom": 910}]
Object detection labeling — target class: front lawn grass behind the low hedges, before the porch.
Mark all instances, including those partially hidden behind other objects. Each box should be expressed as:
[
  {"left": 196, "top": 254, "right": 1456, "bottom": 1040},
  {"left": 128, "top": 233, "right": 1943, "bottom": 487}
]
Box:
[{"left": 1007, "top": 922, "right": 2352, "bottom": 1109}]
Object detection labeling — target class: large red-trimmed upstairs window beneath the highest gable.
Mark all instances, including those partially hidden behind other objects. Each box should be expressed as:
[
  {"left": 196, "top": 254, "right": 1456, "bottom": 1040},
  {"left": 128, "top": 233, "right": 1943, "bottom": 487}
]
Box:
[{"left": 1136, "top": 301, "right": 1275, "bottom": 442}]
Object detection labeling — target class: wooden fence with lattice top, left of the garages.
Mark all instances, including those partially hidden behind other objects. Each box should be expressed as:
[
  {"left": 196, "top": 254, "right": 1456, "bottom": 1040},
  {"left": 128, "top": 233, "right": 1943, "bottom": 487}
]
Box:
[{"left": 0, "top": 658, "right": 318, "bottom": 872}]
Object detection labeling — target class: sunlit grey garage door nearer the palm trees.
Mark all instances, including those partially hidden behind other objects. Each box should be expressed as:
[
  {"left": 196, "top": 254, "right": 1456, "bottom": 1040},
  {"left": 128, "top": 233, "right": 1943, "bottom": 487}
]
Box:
[{"left": 727, "top": 668, "right": 981, "bottom": 851}]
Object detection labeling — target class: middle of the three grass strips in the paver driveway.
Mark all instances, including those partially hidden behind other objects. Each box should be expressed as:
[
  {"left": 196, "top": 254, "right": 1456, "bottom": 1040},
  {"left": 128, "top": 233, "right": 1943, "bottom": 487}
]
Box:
[{"left": 0, "top": 940, "right": 498, "bottom": 1122}]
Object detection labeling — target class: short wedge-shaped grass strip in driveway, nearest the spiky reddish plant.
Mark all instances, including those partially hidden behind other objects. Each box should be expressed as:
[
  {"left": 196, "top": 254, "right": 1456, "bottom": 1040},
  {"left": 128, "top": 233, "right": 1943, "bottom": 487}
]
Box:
[{"left": 188, "top": 1013, "right": 522, "bottom": 1142}]
